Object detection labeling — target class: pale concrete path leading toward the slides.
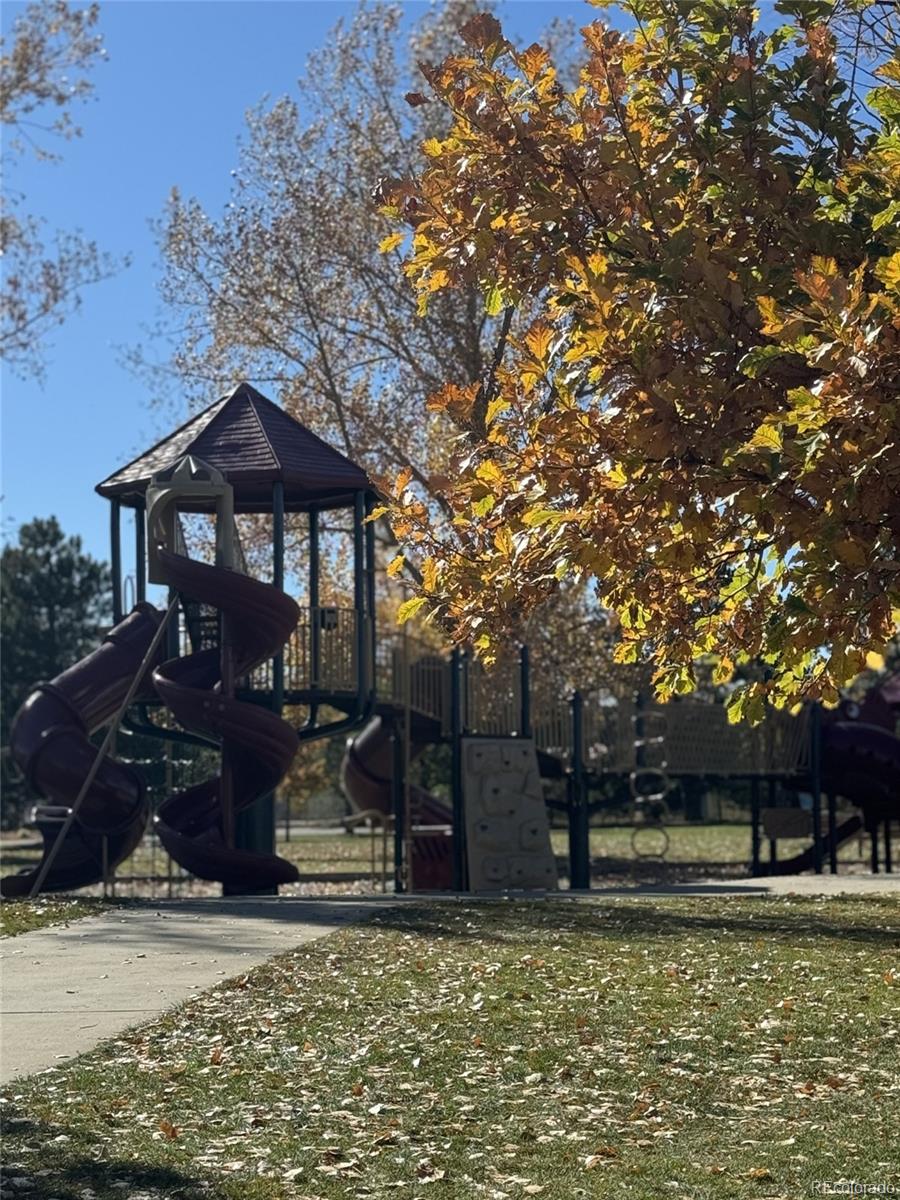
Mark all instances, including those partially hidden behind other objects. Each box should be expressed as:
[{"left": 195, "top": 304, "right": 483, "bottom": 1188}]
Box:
[{"left": 0, "top": 898, "right": 374, "bottom": 1082}]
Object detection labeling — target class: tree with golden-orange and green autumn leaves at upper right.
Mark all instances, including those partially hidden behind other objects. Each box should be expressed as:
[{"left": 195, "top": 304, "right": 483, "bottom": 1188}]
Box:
[{"left": 382, "top": 0, "right": 900, "bottom": 715}]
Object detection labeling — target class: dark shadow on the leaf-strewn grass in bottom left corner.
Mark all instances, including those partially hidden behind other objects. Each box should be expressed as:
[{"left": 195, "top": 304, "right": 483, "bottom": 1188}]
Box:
[{"left": 2, "top": 1105, "right": 214, "bottom": 1200}]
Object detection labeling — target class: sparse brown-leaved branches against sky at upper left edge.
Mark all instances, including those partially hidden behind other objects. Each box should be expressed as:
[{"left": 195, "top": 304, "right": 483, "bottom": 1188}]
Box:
[{"left": 0, "top": 0, "right": 120, "bottom": 376}]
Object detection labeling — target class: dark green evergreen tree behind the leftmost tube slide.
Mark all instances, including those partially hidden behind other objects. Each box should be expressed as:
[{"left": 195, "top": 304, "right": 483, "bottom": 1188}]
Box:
[{"left": 0, "top": 517, "right": 112, "bottom": 826}]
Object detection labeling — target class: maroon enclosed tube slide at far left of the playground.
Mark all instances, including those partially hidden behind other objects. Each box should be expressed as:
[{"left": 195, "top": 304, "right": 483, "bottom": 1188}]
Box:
[{"left": 0, "top": 604, "right": 161, "bottom": 896}]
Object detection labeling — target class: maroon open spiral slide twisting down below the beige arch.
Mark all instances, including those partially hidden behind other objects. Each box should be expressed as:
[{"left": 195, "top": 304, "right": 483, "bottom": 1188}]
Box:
[{"left": 154, "top": 551, "right": 300, "bottom": 888}]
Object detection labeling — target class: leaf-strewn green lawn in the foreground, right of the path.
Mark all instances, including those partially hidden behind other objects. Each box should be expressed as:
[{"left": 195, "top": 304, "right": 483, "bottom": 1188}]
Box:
[{"left": 4, "top": 896, "right": 900, "bottom": 1200}]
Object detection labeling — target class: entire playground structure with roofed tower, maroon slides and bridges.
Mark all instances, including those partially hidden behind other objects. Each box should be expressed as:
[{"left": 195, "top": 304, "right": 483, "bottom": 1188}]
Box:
[{"left": 1, "top": 384, "right": 900, "bottom": 895}]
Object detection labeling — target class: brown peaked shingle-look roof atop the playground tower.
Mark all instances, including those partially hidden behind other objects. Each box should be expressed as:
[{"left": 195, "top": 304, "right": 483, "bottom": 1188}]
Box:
[{"left": 96, "top": 383, "right": 372, "bottom": 512}]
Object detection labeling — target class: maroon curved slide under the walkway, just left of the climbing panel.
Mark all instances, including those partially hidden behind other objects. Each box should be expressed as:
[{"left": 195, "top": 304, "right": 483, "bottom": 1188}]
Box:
[{"left": 341, "top": 716, "right": 454, "bottom": 890}]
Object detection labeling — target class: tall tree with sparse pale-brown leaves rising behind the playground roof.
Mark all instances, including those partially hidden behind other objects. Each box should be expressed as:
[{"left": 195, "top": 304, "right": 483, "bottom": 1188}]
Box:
[{"left": 153, "top": 0, "right": 619, "bottom": 681}]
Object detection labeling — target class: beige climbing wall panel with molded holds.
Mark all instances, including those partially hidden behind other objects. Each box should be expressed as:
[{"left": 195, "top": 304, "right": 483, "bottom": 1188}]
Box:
[{"left": 462, "top": 738, "right": 557, "bottom": 892}]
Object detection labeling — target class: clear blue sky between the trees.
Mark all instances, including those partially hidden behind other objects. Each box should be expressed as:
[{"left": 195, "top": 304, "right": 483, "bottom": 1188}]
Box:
[{"left": 2, "top": 0, "right": 596, "bottom": 569}]
